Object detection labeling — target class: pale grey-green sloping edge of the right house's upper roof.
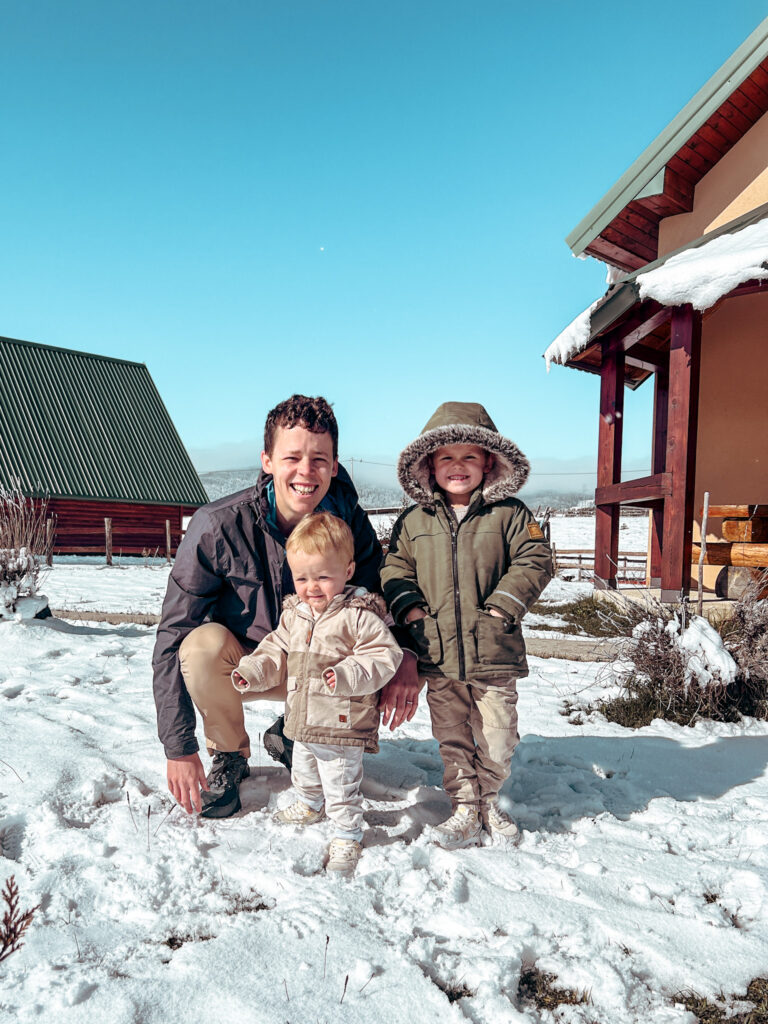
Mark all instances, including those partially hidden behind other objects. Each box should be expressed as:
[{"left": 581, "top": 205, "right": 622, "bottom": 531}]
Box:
[{"left": 565, "top": 17, "right": 768, "bottom": 256}]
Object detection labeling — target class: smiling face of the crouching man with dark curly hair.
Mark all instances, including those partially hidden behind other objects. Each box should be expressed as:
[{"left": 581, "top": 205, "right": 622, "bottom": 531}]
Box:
[{"left": 261, "top": 425, "right": 339, "bottom": 534}]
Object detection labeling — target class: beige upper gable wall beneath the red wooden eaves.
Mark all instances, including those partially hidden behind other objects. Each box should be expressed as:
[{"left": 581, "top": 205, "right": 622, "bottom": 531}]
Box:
[{"left": 658, "top": 107, "right": 768, "bottom": 257}]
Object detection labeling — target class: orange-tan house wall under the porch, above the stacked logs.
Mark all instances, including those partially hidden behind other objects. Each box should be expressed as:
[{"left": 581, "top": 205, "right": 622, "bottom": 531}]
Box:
[{"left": 692, "top": 295, "right": 768, "bottom": 590}]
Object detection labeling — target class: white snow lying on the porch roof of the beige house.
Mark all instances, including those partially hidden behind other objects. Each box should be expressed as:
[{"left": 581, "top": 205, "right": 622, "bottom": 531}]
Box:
[{"left": 544, "top": 217, "right": 768, "bottom": 371}]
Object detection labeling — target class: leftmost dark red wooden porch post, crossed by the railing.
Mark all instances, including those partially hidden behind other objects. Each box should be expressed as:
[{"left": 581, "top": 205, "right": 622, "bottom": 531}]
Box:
[{"left": 595, "top": 342, "right": 624, "bottom": 590}]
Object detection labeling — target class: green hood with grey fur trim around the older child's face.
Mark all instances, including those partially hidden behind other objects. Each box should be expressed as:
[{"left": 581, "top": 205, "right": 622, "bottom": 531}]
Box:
[{"left": 397, "top": 401, "right": 530, "bottom": 508}]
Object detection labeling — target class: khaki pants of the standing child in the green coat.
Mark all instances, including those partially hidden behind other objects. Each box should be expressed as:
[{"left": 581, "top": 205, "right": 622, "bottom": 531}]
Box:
[{"left": 427, "top": 677, "right": 520, "bottom": 809}]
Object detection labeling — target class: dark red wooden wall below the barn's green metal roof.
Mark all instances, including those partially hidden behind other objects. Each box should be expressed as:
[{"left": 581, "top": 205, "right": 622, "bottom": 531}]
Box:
[{"left": 37, "top": 498, "right": 195, "bottom": 556}]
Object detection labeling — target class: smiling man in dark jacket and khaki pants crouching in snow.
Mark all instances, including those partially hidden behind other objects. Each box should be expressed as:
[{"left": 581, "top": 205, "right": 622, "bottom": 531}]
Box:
[{"left": 153, "top": 395, "right": 419, "bottom": 817}]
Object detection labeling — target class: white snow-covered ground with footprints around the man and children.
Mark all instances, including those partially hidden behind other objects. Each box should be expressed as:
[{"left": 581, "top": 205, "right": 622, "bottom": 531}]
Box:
[{"left": 0, "top": 566, "right": 768, "bottom": 1024}]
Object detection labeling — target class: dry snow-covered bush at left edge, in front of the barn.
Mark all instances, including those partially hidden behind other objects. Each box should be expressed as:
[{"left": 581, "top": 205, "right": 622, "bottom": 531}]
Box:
[{"left": 0, "top": 484, "right": 47, "bottom": 620}]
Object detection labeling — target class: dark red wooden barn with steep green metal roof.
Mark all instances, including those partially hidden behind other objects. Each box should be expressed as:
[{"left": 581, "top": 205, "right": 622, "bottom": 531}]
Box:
[{"left": 0, "top": 338, "right": 208, "bottom": 555}]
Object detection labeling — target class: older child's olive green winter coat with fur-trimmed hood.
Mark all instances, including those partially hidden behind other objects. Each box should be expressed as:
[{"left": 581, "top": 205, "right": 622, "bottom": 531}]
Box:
[{"left": 382, "top": 402, "right": 552, "bottom": 682}]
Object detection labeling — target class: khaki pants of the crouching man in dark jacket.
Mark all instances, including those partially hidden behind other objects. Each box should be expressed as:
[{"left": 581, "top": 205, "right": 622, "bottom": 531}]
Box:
[{"left": 179, "top": 623, "right": 286, "bottom": 758}]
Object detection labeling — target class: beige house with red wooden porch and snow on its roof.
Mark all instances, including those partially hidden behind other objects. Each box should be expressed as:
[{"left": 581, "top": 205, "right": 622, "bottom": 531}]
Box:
[{"left": 545, "top": 18, "right": 768, "bottom": 601}]
